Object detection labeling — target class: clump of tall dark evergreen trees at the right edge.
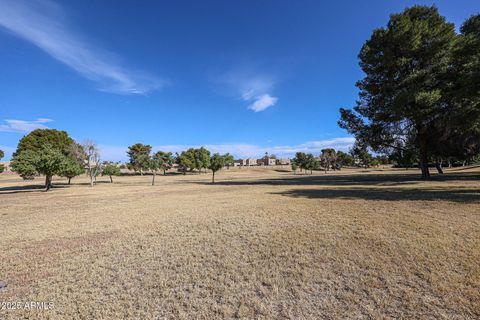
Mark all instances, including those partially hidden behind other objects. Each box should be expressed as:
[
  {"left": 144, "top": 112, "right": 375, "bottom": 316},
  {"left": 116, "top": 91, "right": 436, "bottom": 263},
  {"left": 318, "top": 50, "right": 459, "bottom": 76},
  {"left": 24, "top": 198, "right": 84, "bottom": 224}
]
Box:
[{"left": 339, "top": 6, "right": 480, "bottom": 179}]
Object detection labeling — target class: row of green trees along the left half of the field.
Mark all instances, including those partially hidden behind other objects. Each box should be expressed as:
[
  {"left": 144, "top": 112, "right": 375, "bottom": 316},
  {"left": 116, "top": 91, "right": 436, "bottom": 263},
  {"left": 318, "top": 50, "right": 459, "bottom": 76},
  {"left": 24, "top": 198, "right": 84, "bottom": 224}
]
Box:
[{"left": 4, "top": 129, "right": 233, "bottom": 191}]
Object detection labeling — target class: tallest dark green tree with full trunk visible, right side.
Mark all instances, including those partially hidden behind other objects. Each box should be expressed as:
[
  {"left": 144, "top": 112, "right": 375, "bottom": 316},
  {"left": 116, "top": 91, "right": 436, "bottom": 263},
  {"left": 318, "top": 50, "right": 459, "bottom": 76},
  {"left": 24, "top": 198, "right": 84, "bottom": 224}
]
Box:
[{"left": 339, "top": 6, "right": 456, "bottom": 179}]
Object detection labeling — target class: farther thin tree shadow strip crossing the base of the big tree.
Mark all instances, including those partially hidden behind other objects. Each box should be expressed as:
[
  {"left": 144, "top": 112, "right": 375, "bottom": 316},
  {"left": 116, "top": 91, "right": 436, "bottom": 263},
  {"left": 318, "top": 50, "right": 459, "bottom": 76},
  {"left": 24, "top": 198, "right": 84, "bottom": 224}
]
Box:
[{"left": 192, "top": 173, "right": 480, "bottom": 186}]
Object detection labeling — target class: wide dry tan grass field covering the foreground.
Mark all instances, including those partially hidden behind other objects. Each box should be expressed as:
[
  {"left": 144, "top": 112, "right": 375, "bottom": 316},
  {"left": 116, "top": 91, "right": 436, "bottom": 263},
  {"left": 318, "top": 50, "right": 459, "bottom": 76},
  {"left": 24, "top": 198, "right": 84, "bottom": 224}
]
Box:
[{"left": 0, "top": 168, "right": 480, "bottom": 319}]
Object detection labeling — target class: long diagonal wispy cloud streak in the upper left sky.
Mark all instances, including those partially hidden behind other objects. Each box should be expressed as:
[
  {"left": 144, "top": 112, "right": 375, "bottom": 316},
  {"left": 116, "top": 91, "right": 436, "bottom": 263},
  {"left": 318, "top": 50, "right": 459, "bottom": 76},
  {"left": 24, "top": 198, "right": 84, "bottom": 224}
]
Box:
[{"left": 0, "top": 0, "right": 165, "bottom": 94}]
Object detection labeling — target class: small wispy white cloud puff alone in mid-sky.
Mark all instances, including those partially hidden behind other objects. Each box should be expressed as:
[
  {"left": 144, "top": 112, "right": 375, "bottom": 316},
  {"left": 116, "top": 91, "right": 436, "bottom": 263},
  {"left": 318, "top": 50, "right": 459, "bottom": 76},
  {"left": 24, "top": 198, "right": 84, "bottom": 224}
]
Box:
[{"left": 217, "top": 68, "right": 278, "bottom": 112}]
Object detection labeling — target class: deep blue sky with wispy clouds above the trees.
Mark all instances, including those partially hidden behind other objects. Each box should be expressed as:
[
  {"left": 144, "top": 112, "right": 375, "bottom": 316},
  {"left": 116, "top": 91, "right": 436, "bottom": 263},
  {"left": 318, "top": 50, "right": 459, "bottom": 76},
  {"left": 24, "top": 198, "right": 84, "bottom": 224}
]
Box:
[{"left": 0, "top": 0, "right": 480, "bottom": 160}]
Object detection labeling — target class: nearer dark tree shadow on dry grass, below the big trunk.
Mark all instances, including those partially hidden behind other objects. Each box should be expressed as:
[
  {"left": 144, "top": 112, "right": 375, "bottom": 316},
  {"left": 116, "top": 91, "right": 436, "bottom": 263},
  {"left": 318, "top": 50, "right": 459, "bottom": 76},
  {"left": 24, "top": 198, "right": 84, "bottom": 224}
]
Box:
[{"left": 271, "top": 187, "right": 480, "bottom": 203}]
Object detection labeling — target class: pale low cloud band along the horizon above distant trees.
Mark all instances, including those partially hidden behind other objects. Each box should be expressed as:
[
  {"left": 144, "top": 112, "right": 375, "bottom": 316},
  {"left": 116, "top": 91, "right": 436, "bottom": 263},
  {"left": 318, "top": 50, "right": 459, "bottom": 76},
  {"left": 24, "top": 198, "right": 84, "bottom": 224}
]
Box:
[{"left": 99, "top": 137, "right": 355, "bottom": 161}]
